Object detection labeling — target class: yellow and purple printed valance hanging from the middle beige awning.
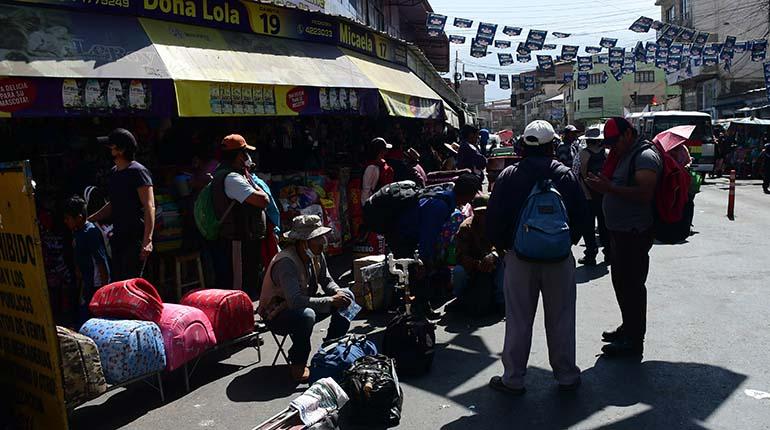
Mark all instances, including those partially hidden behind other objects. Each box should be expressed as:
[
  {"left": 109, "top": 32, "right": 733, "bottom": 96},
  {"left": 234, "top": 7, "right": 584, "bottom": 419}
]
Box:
[{"left": 174, "top": 81, "right": 378, "bottom": 117}]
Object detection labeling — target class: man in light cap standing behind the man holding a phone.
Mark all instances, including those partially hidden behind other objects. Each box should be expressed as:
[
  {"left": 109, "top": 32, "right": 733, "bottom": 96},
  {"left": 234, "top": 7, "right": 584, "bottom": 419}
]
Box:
[{"left": 575, "top": 126, "right": 611, "bottom": 266}]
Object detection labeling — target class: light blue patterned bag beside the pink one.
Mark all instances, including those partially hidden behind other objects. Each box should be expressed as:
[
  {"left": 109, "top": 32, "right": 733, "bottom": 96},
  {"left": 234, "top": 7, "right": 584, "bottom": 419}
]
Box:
[{"left": 80, "top": 318, "right": 166, "bottom": 384}]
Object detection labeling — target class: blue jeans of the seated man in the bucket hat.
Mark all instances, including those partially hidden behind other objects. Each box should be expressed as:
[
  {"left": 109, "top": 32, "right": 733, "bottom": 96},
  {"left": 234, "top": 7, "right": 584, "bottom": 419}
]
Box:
[{"left": 267, "top": 294, "right": 350, "bottom": 365}]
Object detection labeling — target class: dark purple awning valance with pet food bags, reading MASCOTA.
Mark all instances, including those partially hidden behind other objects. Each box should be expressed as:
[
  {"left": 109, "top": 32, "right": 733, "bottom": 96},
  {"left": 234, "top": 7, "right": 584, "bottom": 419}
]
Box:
[{"left": 0, "top": 78, "right": 174, "bottom": 117}]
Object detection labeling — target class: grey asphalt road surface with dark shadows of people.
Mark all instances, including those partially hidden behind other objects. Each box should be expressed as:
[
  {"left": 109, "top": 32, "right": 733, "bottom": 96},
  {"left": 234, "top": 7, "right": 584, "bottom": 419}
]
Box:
[{"left": 67, "top": 180, "right": 770, "bottom": 430}]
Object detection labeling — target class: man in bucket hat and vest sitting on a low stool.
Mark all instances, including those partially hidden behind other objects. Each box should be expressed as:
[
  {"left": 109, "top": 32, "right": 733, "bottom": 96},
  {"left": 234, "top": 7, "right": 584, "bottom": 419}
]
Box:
[{"left": 257, "top": 215, "right": 355, "bottom": 382}]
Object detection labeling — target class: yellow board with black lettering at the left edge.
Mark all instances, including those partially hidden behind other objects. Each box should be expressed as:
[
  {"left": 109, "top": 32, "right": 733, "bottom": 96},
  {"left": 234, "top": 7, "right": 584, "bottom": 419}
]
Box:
[{"left": 0, "top": 161, "right": 67, "bottom": 429}]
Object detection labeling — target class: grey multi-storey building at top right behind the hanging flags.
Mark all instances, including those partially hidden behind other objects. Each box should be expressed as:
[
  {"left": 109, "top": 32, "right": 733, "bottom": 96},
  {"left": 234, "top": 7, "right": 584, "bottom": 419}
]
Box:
[{"left": 656, "top": 0, "right": 770, "bottom": 119}]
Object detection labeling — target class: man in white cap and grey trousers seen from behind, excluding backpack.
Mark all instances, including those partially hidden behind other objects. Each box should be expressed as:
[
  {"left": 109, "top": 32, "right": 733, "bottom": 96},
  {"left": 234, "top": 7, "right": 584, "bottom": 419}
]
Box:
[{"left": 487, "top": 120, "right": 586, "bottom": 395}]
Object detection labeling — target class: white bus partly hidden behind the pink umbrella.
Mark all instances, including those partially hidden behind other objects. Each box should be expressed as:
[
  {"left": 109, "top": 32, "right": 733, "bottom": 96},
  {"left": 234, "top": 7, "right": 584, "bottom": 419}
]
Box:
[{"left": 632, "top": 111, "right": 716, "bottom": 174}]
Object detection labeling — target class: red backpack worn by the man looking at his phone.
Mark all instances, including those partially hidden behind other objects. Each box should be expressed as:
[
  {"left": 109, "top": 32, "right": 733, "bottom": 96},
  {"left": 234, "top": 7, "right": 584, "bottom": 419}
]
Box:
[{"left": 628, "top": 142, "right": 692, "bottom": 243}]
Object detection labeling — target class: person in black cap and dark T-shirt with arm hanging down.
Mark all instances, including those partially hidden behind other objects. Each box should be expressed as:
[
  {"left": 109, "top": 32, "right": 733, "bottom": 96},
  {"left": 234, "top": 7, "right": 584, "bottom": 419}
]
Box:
[{"left": 88, "top": 128, "right": 155, "bottom": 280}]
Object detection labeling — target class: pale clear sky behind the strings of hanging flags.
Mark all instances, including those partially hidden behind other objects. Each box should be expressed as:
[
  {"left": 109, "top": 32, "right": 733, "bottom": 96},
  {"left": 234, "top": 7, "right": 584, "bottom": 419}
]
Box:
[{"left": 430, "top": 0, "right": 660, "bottom": 100}]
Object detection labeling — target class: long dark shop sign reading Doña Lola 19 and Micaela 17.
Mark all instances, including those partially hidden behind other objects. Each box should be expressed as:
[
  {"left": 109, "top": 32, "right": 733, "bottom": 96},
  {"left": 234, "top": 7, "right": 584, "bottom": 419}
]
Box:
[{"left": 10, "top": 0, "right": 407, "bottom": 65}]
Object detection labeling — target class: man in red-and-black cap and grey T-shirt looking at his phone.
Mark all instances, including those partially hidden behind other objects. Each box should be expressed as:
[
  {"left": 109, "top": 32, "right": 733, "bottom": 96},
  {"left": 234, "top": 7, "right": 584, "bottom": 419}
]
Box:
[{"left": 586, "top": 117, "right": 660, "bottom": 357}]
